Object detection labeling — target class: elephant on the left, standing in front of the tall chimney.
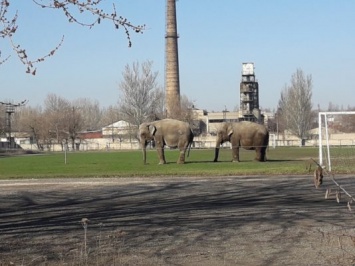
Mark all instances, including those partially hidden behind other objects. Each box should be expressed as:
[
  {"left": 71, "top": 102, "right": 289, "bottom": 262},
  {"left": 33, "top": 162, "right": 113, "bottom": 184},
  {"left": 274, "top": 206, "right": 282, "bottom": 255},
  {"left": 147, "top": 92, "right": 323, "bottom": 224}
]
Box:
[{"left": 139, "top": 119, "right": 194, "bottom": 164}]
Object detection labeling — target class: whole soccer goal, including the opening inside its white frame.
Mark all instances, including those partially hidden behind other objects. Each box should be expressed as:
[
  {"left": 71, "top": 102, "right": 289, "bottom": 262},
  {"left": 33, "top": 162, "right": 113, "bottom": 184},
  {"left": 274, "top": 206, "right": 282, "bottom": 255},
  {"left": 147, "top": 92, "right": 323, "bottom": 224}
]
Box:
[{"left": 318, "top": 111, "right": 355, "bottom": 174}]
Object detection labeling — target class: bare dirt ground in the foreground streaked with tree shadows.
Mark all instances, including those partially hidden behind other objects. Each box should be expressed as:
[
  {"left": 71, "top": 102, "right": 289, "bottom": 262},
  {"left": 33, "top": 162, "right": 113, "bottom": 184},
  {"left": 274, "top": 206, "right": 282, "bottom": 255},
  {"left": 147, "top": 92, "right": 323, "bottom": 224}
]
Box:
[{"left": 0, "top": 176, "right": 355, "bottom": 265}]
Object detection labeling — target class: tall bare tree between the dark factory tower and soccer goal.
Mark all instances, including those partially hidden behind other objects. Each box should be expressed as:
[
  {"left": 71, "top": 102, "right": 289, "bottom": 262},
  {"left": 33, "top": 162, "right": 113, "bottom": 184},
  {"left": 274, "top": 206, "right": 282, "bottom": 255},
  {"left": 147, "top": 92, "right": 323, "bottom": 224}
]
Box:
[{"left": 278, "top": 69, "right": 313, "bottom": 144}]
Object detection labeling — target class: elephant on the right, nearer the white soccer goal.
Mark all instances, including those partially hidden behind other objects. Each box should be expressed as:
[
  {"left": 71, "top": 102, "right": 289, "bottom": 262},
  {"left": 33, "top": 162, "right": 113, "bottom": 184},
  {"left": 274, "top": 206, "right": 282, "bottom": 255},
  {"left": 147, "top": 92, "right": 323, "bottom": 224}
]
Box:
[{"left": 214, "top": 121, "right": 269, "bottom": 162}]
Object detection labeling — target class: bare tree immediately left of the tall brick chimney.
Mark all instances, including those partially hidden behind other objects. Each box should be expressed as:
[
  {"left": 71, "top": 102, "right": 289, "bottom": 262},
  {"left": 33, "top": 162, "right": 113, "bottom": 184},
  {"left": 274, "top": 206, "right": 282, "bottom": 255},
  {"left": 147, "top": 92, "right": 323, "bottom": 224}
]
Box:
[{"left": 119, "top": 61, "right": 164, "bottom": 127}]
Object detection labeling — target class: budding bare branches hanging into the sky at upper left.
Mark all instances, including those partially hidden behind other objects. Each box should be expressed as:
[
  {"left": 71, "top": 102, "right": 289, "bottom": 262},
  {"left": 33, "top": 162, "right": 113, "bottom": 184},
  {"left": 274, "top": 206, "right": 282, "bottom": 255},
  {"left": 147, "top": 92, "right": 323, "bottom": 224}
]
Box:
[{"left": 0, "top": 0, "right": 145, "bottom": 75}]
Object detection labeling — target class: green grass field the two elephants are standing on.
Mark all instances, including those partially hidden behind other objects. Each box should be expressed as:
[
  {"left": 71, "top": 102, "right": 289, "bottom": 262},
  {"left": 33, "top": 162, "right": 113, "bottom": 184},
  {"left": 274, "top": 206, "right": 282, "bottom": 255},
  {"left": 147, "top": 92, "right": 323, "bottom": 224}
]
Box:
[{"left": 0, "top": 147, "right": 318, "bottom": 179}]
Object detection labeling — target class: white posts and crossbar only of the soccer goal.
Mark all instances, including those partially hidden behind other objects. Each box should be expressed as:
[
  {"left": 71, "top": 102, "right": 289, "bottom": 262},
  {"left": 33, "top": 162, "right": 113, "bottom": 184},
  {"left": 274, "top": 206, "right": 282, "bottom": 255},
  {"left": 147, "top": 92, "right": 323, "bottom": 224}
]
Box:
[{"left": 318, "top": 111, "right": 355, "bottom": 172}]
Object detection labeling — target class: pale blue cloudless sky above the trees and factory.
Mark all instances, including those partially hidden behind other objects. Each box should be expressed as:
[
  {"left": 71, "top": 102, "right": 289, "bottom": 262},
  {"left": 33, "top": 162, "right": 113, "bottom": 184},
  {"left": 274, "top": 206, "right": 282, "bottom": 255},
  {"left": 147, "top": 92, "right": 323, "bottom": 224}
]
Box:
[{"left": 0, "top": 0, "right": 355, "bottom": 111}]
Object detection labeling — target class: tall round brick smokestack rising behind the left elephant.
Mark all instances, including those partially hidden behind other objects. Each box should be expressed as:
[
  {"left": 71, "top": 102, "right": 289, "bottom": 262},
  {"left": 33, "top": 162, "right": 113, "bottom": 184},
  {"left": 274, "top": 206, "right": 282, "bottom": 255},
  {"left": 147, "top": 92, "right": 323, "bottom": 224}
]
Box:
[{"left": 165, "top": 0, "right": 180, "bottom": 118}]
